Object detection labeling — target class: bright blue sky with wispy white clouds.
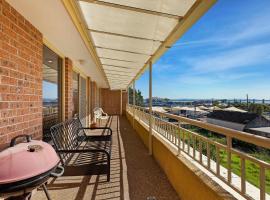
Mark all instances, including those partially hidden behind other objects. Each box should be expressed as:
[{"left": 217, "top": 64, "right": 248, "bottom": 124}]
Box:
[{"left": 136, "top": 0, "right": 270, "bottom": 99}]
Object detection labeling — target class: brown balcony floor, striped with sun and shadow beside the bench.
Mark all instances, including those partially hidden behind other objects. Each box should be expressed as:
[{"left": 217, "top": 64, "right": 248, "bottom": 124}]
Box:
[{"left": 32, "top": 116, "right": 179, "bottom": 200}]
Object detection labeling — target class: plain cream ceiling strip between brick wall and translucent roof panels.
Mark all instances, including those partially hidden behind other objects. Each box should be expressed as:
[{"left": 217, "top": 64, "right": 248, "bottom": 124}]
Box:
[{"left": 7, "top": 0, "right": 108, "bottom": 88}]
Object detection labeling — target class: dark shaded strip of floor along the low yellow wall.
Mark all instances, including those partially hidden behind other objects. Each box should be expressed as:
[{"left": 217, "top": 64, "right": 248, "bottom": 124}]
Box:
[{"left": 119, "top": 116, "right": 179, "bottom": 200}]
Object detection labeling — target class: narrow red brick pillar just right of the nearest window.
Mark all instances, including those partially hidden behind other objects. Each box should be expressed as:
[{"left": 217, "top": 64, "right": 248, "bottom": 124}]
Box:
[{"left": 65, "top": 58, "right": 74, "bottom": 119}]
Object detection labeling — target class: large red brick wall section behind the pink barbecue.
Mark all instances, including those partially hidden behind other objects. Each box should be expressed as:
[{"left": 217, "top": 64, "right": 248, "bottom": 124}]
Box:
[{"left": 0, "top": 0, "right": 43, "bottom": 149}]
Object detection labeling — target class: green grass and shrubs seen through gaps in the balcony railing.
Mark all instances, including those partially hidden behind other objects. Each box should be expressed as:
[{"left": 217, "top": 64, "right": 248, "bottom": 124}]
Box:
[{"left": 184, "top": 127, "right": 270, "bottom": 194}]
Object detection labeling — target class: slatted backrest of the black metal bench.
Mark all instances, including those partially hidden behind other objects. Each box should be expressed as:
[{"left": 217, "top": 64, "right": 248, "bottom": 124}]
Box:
[{"left": 51, "top": 117, "right": 86, "bottom": 165}]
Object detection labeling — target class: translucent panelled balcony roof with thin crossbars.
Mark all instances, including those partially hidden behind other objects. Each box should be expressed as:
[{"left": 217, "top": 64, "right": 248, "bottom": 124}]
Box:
[{"left": 77, "top": 0, "right": 214, "bottom": 89}]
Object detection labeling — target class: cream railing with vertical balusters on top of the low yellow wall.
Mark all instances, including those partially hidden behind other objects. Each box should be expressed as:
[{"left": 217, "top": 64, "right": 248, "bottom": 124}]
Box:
[{"left": 127, "top": 105, "right": 270, "bottom": 200}]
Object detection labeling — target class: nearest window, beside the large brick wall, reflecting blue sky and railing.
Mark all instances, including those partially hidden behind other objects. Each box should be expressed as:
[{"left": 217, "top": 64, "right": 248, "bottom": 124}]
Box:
[{"left": 42, "top": 46, "right": 62, "bottom": 141}]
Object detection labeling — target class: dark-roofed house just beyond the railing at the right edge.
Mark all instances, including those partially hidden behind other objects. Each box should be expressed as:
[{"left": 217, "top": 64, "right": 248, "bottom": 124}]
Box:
[{"left": 206, "top": 110, "right": 270, "bottom": 138}]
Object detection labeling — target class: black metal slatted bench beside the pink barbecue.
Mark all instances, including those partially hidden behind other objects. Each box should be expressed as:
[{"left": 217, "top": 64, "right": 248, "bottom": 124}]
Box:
[{"left": 51, "top": 117, "right": 112, "bottom": 181}]
